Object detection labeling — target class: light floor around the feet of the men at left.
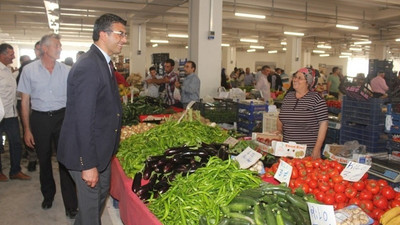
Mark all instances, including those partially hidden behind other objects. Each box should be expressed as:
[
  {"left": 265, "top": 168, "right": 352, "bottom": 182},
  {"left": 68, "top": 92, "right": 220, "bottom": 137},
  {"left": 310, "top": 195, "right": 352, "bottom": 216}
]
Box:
[{"left": 0, "top": 139, "right": 123, "bottom": 225}]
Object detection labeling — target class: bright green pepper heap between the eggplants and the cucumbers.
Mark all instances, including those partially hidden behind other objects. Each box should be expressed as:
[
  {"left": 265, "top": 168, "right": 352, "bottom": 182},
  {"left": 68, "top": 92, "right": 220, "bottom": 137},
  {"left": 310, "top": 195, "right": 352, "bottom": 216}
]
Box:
[{"left": 149, "top": 157, "right": 261, "bottom": 225}]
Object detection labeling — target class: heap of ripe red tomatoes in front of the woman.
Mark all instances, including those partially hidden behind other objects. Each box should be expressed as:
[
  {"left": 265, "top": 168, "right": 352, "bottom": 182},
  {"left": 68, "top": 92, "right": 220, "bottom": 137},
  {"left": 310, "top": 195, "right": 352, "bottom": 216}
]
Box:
[{"left": 263, "top": 157, "right": 400, "bottom": 221}]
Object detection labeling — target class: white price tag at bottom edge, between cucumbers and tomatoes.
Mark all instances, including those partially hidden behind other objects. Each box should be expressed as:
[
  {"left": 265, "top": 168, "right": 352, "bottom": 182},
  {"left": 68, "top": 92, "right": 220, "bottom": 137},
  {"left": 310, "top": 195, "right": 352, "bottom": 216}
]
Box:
[{"left": 307, "top": 202, "right": 336, "bottom": 225}]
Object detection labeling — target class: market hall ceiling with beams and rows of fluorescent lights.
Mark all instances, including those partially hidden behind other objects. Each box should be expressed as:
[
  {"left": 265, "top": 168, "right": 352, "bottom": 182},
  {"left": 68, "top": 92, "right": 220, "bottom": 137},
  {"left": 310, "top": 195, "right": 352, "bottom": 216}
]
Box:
[{"left": 0, "top": 0, "right": 400, "bottom": 57}]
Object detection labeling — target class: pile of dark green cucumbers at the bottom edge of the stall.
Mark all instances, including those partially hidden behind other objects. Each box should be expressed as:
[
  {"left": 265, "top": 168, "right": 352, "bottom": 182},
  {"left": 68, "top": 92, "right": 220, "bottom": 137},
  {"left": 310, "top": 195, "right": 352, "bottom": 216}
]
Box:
[{"left": 219, "top": 183, "right": 318, "bottom": 225}]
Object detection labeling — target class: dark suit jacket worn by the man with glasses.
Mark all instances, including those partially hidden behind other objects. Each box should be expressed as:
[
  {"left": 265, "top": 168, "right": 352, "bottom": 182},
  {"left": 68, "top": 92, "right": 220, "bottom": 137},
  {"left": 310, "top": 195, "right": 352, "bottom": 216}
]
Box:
[{"left": 57, "top": 45, "right": 122, "bottom": 172}]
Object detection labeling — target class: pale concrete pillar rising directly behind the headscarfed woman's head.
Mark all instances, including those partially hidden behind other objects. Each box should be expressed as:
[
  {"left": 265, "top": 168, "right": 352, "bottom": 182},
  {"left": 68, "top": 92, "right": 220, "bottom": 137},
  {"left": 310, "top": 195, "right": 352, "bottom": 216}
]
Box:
[{"left": 285, "top": 37, "right": 302, "bottom": 74}]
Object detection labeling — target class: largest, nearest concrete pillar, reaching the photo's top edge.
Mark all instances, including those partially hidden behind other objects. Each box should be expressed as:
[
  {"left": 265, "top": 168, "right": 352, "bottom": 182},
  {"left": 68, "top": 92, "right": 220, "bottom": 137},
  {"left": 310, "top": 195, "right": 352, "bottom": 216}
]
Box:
[{"left": 188, "top": 0, "right": 222, "bottom": 98}]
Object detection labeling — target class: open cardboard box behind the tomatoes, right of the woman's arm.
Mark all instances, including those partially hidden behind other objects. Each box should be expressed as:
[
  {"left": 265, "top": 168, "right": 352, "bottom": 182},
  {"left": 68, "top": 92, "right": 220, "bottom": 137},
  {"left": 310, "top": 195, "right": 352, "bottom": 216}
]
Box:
[{"left": 323, "top": 144, "right": 372, "bottom": 165}]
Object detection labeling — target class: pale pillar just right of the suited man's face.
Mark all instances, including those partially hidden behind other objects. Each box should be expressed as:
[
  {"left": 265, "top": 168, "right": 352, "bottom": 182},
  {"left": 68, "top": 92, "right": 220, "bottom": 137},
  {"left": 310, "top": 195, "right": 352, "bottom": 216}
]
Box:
[{"left": 129, "top": 23, "right": 146, "bottom": 77}]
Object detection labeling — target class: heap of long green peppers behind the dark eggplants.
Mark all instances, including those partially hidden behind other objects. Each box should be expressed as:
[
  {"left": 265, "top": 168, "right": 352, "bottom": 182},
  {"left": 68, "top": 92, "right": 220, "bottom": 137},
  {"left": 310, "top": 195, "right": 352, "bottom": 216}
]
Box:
[{"left": 117, "top": 120, "right": 228, "bottom": 178}]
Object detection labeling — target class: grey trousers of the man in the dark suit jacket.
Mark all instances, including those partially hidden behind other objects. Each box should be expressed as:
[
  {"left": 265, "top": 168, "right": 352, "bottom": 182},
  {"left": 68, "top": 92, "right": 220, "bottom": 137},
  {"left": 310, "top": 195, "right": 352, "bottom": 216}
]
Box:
[{"left": 69, "top": 163, "right": 111, "bottom": 225}]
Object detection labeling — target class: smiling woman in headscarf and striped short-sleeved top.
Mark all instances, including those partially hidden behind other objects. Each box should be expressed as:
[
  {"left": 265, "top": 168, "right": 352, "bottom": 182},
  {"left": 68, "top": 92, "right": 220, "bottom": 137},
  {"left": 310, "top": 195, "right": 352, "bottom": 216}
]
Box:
[{"left": 277, "top": 68, "right": 328, "bottom": 158}]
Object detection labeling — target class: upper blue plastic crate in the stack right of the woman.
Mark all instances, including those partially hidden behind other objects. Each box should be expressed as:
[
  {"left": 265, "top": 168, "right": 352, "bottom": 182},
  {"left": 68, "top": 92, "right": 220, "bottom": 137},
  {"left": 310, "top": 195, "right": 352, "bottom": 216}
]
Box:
[{"left": 342, "top": 96, "right": 385, "bottom": 125}]
